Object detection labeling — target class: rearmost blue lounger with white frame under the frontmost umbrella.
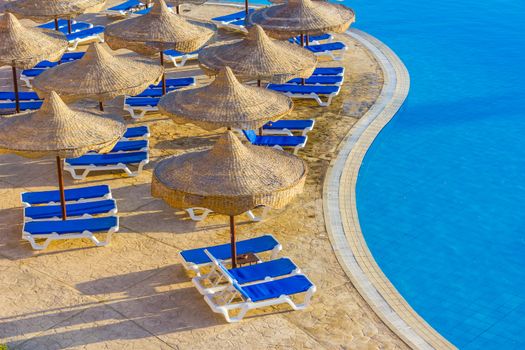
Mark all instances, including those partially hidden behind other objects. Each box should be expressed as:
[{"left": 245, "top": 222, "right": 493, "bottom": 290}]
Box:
[{"left": 179, "top": 235, "right": 282, "bottom": 276}]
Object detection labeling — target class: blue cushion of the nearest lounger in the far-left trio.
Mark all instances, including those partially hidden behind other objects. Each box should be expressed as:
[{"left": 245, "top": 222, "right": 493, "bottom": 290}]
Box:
[{"left": 24, "top": 216, "right": 118, "bottom": 235}]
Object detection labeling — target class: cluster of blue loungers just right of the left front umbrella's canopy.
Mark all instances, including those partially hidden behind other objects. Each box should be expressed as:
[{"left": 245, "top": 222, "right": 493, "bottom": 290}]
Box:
[{"left": 64, "top": 126, "right": 150, "bottom": 180}]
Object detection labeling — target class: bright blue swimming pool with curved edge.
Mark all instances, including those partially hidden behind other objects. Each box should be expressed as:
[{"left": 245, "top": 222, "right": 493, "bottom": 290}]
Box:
[{"left": 348, "top": 0, "right": 525, "bottom": 349}]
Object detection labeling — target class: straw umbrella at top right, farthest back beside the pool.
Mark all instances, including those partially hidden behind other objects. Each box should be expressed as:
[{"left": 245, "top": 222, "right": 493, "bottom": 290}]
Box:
[{"left": 247, "top": 0, "right": 355, "bottom": 45}]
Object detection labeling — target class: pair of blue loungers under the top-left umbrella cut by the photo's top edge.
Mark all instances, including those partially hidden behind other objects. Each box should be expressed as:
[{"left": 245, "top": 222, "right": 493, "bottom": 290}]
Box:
[{"left": 39, "top": 19, "right": 104, "bottom": 51}]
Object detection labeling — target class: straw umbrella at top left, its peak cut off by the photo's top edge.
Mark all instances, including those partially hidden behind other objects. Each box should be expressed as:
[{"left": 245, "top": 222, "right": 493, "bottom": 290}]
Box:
[{"left": 6, "top": 0, "right": 106, "bottom": 33}]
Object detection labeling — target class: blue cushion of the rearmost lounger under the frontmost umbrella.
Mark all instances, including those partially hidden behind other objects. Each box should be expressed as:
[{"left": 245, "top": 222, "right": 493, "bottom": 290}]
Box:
[{"left": 180, "top": 235, "right": 279, "bottom": 265}]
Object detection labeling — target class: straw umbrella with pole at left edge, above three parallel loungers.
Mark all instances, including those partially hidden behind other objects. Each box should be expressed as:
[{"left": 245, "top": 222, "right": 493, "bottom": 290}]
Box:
[{"left": 0, "top": 92, "right": 126, "bottom": 220}]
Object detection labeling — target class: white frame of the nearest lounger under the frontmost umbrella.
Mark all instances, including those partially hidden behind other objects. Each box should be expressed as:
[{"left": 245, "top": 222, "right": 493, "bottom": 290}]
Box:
[{"left": 204, "top": 278, "right": 316, "bottom": 323}]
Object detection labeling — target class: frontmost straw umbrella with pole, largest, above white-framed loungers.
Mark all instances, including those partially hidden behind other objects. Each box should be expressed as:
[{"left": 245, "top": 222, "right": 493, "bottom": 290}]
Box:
[{"left": 151, "top": 131, "right": 307, "bottom": 266}]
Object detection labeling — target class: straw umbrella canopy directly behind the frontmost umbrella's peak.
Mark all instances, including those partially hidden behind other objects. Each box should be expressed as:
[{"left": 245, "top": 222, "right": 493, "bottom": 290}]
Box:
[{"left": 159, "top": 67, "right": 293, "bottom": 130}]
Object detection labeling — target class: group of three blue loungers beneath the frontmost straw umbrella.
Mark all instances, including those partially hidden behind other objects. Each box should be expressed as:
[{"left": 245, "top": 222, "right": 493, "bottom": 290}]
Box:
[{"left": 180, "top": 235, "right": 316, "bottom": 322}]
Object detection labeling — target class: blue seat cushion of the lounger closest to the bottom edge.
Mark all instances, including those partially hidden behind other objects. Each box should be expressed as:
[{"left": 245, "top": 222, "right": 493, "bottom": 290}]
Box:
[{"left": 233, "top": 275, "right": 314, "bottom": 302}]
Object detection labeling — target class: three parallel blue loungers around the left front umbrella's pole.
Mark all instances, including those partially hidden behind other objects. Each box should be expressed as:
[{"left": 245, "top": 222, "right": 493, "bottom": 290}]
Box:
[{"left": 21, "top": 185, "right": 119, "bottom": 250}]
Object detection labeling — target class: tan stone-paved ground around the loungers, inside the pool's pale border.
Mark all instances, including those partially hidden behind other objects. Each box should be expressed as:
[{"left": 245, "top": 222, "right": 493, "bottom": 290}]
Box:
[{"left": 0, "top": 1, "right": 406, "bottom": 349}]
